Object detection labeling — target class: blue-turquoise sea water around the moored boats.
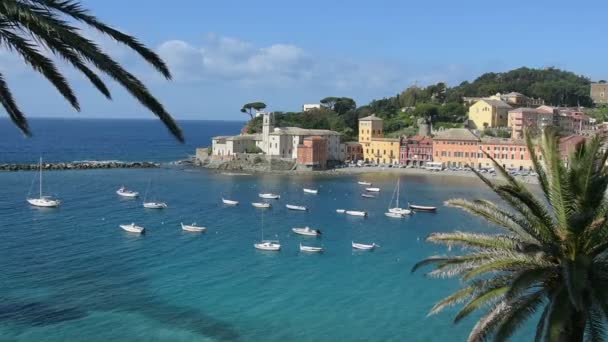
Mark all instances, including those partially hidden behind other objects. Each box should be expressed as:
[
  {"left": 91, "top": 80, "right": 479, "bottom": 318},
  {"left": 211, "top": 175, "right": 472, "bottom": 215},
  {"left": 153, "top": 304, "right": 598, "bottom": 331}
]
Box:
[{"left": 0, "top": 119, "right": 535, "bottom": 342}]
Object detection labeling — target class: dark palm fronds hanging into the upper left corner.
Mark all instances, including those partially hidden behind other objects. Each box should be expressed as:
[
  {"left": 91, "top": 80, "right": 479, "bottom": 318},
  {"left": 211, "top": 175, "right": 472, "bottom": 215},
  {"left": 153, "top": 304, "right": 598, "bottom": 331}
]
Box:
[{"left": 0, "top": 0, "right": 184, "bottom": 142}]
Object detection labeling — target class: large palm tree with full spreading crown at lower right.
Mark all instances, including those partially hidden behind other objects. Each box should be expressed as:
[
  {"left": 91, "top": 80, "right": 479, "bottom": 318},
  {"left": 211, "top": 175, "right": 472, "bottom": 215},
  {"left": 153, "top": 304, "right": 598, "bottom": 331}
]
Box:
[{"left": 412, "top": 130, "right": 608, "bottom": 341}]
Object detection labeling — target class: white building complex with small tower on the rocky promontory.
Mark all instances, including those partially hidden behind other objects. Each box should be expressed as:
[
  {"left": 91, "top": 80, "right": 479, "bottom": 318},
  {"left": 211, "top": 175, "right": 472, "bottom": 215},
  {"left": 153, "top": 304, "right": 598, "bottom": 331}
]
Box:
[{"left": 212, "top": 113, "right": 346, "bottom": 161}]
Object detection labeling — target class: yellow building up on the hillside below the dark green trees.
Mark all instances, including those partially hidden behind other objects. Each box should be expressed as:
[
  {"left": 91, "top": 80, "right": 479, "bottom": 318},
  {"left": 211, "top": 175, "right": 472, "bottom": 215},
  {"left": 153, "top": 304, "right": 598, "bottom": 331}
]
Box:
[{"left": 469, "top": 99, "right": 511, "bottom": 129}]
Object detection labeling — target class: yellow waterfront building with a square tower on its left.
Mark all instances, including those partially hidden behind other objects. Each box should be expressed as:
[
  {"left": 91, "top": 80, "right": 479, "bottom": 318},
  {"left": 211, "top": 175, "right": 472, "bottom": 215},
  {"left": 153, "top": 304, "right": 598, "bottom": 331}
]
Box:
[{"left": 359, "top": 114, "right": 400, "bottom": 164}]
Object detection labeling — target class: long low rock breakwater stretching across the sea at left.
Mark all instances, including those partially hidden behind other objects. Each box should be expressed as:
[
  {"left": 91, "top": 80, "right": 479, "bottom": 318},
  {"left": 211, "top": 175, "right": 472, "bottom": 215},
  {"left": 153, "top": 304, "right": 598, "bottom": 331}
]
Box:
[{"left": 0, "top": 160, "right": 160, "bottom": 171}]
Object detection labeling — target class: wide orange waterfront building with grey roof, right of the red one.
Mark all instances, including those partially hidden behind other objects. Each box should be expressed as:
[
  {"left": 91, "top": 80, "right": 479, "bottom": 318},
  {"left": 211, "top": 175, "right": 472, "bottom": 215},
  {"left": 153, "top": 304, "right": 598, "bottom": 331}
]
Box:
[{"left": 433, "top": 128, "right": 481, "bottom": 167}]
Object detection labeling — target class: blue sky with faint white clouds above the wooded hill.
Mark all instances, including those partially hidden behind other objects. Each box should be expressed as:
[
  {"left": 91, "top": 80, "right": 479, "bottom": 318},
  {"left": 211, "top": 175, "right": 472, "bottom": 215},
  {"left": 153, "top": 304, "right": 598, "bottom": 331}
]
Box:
[{"left": 0, "top": 0, "right": 608, "bottom": 120}]
